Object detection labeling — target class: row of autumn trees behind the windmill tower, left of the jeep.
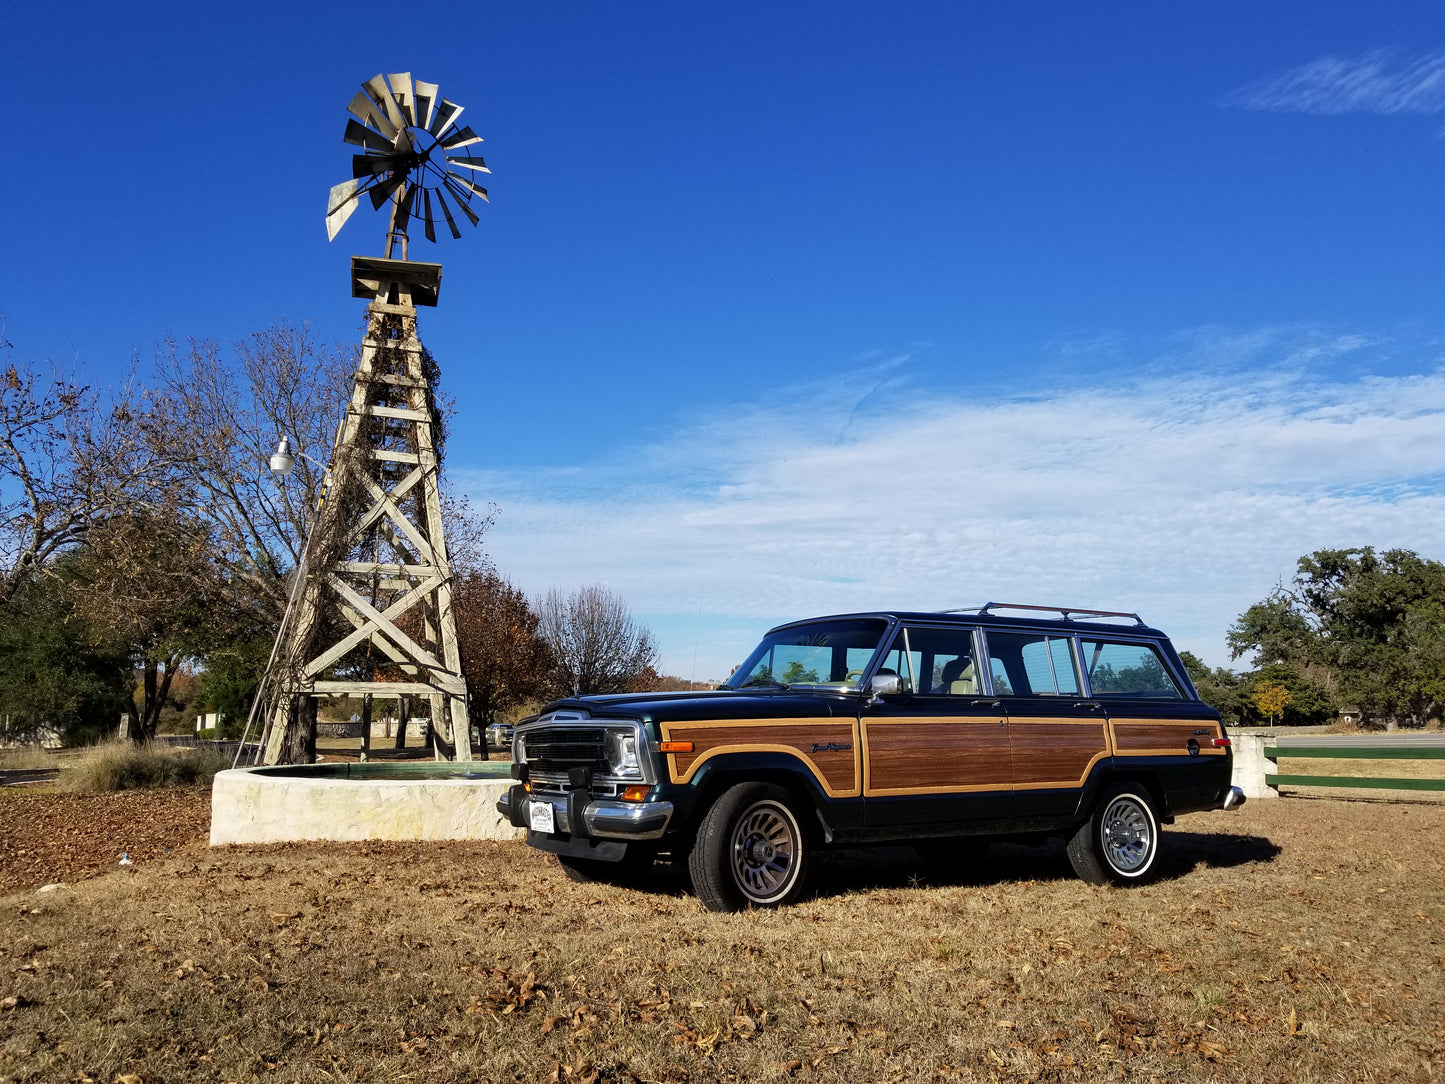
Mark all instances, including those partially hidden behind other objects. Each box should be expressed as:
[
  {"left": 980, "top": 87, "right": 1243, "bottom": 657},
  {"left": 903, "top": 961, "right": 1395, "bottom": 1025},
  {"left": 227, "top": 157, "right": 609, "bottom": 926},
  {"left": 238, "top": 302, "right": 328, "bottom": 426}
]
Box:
[{"left": 0, "top": 324, "right": 663, "bottom": 757}]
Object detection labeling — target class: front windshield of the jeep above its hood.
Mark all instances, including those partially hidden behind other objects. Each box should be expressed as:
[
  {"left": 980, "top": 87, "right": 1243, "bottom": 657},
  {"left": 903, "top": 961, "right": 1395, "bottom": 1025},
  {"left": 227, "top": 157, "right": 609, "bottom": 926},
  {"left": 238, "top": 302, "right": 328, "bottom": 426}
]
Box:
[{"left": 723, "top": 617, "right": 887, "bottom": 689}]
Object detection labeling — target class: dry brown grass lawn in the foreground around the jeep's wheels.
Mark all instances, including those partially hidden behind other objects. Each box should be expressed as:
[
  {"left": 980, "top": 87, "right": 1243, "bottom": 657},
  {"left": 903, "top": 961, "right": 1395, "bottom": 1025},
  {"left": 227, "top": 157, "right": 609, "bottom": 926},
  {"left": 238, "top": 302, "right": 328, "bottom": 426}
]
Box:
[{"left": 0, "top": 799, "right": 1445, "bottom": 1084}]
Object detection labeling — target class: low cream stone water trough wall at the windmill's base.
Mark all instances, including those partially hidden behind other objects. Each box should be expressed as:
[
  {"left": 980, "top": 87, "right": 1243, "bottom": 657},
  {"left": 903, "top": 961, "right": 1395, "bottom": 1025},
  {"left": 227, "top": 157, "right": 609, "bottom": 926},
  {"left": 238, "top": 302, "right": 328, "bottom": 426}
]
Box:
[{"left": 203, "top": 760, "right": 525, "bottom": 847}]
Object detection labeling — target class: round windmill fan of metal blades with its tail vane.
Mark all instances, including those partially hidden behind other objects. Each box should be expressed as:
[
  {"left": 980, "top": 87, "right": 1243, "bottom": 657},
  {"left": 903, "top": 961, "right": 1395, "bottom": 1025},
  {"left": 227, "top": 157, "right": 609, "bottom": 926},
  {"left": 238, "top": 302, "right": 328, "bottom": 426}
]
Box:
[{"left": 327, "top": 72, "right": 491, "bottom": 256}]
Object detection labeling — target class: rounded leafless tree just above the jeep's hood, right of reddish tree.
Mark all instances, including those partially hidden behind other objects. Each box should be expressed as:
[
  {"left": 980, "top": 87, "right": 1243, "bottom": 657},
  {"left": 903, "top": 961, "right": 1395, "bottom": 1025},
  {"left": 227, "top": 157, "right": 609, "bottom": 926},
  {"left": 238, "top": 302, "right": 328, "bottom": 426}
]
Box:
[{"left": 538, "top": 584, "right": 657, "bottom": 695}]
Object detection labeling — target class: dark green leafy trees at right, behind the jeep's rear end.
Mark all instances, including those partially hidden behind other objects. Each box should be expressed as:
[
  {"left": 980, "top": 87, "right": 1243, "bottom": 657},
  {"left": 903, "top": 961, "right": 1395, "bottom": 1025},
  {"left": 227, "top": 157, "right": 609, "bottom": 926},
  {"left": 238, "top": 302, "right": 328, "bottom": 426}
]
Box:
[{"left": 1183, "top": 546, "right": 1445, "bottom": 730}]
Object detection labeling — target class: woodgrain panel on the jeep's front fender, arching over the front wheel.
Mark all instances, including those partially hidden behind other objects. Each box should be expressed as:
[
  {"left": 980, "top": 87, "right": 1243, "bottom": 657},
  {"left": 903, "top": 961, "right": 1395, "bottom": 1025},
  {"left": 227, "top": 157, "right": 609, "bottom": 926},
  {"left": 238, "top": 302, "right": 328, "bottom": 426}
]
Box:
[{"left": 660, "top": 717, "right": 863, "bottom": 798}]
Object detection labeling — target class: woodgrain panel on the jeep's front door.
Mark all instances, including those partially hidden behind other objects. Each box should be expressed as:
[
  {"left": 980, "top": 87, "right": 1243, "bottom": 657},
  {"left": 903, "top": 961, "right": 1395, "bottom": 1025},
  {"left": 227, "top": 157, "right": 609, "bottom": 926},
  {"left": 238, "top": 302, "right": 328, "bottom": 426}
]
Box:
[{"left": 864, "top": 718, "right": 1012, "bottom": 795}]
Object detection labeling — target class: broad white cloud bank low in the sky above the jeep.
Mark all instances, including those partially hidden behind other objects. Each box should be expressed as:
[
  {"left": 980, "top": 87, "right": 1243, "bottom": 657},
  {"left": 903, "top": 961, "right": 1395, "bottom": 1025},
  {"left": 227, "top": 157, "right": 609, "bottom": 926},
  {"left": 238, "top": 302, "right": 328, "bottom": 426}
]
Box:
[{"left": 457, "top": 337, "right": 1445, "bottom": 676}]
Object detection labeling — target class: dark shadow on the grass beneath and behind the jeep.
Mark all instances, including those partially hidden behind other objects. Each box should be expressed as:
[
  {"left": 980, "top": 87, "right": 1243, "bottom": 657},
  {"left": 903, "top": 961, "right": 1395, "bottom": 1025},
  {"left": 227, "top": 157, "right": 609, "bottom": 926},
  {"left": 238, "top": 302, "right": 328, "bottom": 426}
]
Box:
[{"left": 637, "top": 831, "right": 1282, "bottom": 899}]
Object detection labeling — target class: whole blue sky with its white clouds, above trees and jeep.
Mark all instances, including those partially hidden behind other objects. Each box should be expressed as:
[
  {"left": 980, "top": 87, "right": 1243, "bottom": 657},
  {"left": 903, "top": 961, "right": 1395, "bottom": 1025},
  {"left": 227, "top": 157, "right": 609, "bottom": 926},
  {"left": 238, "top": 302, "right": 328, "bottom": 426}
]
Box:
[{"left": 0, "top": 3, "right": 1445, "bottom": 678}]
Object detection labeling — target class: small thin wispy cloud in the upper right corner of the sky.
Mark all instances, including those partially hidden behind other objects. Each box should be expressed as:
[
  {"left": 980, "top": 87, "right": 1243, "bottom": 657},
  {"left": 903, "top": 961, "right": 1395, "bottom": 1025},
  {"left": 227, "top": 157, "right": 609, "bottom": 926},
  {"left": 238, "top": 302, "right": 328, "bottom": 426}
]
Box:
[{"left": 1221, "top": 49, "right": 1445, "bottom": 116}]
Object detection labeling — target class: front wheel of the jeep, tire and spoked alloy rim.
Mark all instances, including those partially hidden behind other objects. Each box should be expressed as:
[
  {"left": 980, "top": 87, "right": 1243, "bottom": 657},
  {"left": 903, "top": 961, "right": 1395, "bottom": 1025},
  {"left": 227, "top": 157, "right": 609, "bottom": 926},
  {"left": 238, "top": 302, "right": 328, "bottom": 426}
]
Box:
[{"left": 688, "top": 783, "right": 812, "bottom": 911}]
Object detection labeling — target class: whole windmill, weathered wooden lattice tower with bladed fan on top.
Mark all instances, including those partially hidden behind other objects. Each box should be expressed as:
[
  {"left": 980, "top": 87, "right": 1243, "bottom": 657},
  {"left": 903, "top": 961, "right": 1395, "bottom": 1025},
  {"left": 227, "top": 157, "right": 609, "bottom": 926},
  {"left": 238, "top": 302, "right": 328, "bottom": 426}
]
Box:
[{"left": 262, "top": 72, "right": 490, "bottom": 765}]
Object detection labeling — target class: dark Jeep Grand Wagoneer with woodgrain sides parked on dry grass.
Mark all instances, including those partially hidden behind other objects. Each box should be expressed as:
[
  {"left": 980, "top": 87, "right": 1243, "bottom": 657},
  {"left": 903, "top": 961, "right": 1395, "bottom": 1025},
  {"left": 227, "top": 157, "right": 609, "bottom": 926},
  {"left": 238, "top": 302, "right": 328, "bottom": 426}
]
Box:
[{"left": 497, "top": 603, "right": 1244, "bottom": 911}]
